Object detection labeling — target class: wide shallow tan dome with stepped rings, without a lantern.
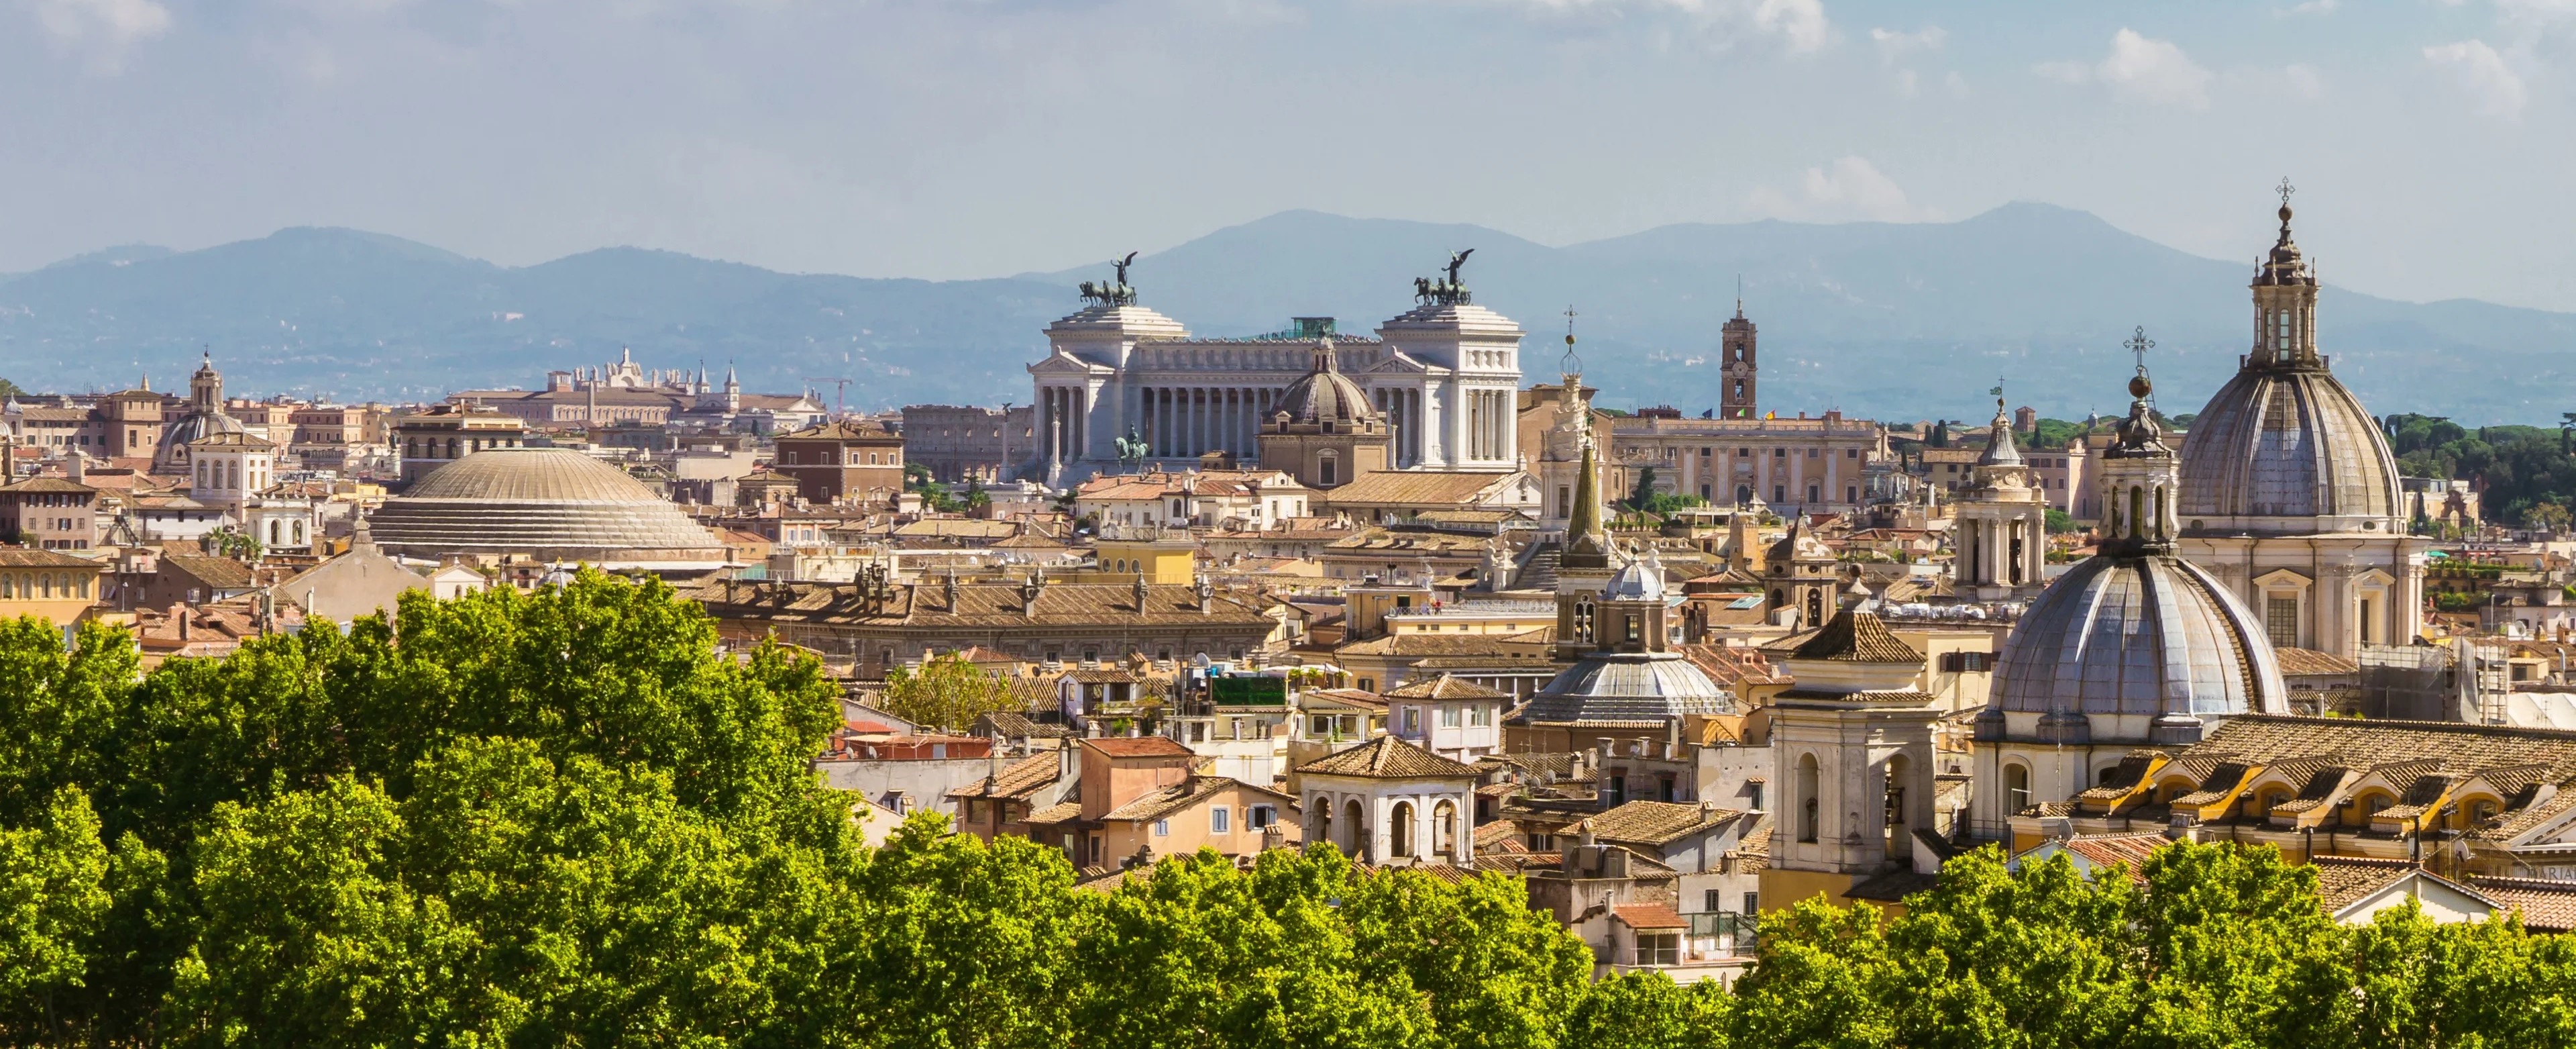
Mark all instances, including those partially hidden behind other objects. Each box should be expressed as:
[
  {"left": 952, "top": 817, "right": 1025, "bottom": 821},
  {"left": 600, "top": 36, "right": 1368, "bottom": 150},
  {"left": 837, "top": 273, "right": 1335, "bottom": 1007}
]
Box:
[{"left": 368, "top": 448, "right": 727, "bottom": 567}]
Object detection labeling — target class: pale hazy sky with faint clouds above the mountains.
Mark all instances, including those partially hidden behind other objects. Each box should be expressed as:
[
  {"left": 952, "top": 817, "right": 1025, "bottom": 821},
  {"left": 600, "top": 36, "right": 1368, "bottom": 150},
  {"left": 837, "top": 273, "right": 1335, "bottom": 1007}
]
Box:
[{"left": 15, "top": 0, "right": 2576, "bottom": 309}]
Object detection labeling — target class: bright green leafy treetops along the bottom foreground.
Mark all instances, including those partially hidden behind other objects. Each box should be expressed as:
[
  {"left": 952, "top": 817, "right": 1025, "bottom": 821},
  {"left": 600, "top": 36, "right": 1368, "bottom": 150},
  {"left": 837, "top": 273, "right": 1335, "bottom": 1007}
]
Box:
[{"left": 0, "top": 575, "right": 2576, "bottom": 1049}]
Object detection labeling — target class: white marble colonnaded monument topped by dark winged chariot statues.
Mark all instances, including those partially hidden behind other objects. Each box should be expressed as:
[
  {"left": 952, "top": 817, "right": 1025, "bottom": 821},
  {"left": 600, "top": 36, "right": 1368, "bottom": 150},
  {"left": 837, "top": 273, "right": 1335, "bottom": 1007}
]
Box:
[{"left": 1020, "top": 273, "right": 1522, "bottom": 485}]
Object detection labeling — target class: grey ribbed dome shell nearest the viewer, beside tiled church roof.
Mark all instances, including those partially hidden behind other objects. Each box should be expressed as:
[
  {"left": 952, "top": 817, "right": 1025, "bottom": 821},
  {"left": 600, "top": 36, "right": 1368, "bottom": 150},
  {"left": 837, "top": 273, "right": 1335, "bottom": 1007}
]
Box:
[{"left": 1988, "top": 554, "right": 2290, "bottom": 717}]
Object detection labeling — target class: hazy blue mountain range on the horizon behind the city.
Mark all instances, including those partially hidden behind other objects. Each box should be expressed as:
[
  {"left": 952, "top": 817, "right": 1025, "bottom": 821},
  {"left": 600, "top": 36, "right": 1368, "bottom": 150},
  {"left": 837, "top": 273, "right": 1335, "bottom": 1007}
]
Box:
[{"left": 0, "top": 203, "right": 2576, "bottom": 423}]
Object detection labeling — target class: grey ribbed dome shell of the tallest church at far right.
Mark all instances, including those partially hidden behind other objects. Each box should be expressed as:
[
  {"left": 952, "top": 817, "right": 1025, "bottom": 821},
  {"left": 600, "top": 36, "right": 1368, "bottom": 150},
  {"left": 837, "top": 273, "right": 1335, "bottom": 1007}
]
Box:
[{"left": 2177, "top": 361, "right": 2401, "bottom": 536}]
